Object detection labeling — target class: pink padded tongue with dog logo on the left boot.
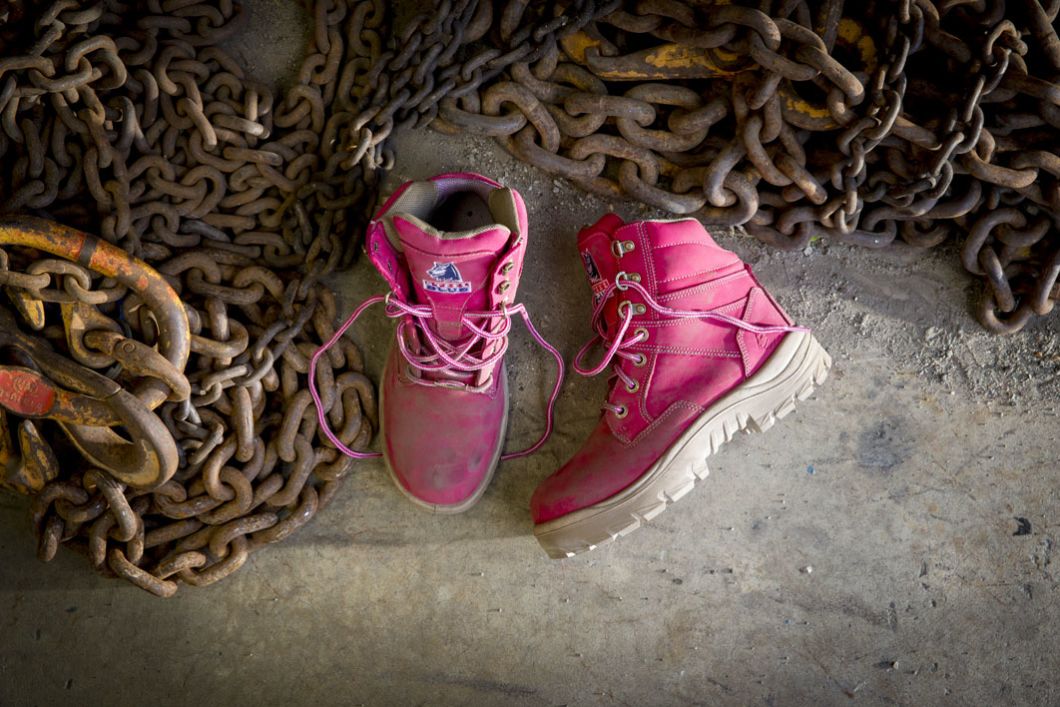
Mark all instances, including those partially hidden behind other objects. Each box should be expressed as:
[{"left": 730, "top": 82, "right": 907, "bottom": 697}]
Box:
[{"left": 391, "top": 214, "right": 511, "bottom": 343}]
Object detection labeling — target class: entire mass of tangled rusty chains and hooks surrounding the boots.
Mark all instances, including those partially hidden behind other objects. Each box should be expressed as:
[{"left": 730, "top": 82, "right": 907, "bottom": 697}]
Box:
[{"left": 0, "top": 0, "right": 1060, "bottom": 596}]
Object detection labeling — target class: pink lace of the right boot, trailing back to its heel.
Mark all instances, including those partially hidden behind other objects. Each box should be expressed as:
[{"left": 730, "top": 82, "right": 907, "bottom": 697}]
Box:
[{"left": 572, "top": 272, "right": 810, "bottom": 416}]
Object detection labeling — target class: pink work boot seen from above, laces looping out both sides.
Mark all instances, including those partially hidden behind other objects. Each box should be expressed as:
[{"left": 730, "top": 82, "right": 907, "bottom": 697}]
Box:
[{"left": 311, "top": 173, "right": 563, "bottom": 513}]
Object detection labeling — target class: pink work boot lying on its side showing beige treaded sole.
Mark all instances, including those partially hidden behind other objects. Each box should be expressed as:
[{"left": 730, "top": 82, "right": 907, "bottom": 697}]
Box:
[{"left": 530, "top": 214, "right": 832, "bottom": 558}]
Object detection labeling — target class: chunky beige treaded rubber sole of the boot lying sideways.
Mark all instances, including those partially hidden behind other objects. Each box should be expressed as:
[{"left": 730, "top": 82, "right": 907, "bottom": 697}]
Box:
[{"left": 534, "top": 332, "right": 832, "bottom": 560}]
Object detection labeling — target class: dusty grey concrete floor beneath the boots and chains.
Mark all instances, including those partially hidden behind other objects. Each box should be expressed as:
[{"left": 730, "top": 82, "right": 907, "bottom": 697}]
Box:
[{"left": 0, "top": 5, "right": 1060, "bottom": 706}]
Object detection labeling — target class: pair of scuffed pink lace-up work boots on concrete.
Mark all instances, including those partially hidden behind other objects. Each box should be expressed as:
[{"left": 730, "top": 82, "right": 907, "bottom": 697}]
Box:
[{"left": 311, "top": 173, "right": 831, "bottom": 558}]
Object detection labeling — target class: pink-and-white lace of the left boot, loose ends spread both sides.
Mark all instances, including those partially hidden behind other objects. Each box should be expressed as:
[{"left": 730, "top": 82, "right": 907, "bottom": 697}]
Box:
[{"left": 310, "top": 293, "right": 566, "bottom": 460}]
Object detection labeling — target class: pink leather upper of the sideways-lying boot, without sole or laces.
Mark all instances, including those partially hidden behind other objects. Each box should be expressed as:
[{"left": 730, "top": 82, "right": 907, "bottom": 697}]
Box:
[{"left": 530, "top": 214, "right": 792, "bottom": 524}]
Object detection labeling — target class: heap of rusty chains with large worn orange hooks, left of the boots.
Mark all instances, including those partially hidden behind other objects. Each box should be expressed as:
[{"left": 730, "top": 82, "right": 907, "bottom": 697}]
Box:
[{"left": 0, "top": 0, "right": 384, "bottom": 596}]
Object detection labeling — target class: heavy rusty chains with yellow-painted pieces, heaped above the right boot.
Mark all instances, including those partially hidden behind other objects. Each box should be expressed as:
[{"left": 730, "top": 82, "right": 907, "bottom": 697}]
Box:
[{"left": 350, "top": 0, "right": 1060, "bottom": 333}]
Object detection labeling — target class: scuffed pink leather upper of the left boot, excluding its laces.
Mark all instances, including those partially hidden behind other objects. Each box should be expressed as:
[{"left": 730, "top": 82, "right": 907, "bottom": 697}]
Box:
[{"left": 366, "top": 173, "right": 527, "bottom": 507}]
